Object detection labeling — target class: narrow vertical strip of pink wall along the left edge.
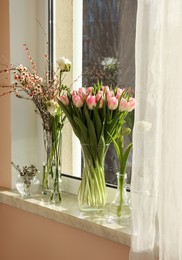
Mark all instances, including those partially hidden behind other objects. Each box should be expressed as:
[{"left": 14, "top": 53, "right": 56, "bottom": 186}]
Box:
[{"left": 0, "top": 0, "right": 11, "bottom": 187}]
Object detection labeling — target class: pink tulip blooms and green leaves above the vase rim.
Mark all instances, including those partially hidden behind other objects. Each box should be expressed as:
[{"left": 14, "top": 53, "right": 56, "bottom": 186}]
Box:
[{"left": 58, "top": 83, "right": 135, "bottom": 145}]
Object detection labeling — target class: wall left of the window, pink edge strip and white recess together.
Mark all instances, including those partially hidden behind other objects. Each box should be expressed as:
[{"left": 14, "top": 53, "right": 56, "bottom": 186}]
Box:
[{"left": 0, "top": 0, "right": 47, "bottom": 188}]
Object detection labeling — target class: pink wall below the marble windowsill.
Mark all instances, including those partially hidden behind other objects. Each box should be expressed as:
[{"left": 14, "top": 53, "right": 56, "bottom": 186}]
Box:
[{"left": 0, "top": 204, "right": 129, "bottom": 260}]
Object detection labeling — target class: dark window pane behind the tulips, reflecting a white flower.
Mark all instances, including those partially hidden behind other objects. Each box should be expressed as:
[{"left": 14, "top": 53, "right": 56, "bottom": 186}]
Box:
[{"left": 82, "top": 0, "right": 137, "bottom": 184}]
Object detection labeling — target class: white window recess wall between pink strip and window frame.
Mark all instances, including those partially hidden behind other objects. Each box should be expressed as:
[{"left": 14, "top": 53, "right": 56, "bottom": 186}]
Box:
[{"left": 9, "top": 0, "right": 47, "bottom": 187}]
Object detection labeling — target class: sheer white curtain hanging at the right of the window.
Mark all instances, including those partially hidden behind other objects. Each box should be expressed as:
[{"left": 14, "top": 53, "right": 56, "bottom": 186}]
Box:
[{"left": 130, "top": 0, "right": 182, "bottom": 260}]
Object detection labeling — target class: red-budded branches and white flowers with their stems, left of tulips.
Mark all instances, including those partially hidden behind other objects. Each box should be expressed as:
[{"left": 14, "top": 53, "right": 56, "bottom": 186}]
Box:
[{"left": 0, "top": 44, "right": 71, "bottom": 203}]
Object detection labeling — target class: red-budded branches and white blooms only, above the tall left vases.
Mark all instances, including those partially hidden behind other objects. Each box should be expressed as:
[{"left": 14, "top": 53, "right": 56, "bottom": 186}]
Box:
[{"left": 0, "top": 44, "right": 71, "bottom": 131}]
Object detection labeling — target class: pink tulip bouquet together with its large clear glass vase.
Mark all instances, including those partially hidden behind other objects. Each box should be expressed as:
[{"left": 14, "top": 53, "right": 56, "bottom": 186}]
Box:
[{"left": 58, "top": 83, "right": 135, "bottom": 211}]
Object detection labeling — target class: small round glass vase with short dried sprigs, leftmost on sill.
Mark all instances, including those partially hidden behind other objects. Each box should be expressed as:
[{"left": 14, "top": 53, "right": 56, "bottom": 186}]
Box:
[{"left": 15, "top": 174, "right": 40, "bottom": 199}]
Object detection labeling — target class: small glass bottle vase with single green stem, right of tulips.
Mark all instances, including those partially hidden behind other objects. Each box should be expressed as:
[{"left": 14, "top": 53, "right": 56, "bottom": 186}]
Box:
[{"left": 108, "top": 172, "right": 131, "bottom": 225}]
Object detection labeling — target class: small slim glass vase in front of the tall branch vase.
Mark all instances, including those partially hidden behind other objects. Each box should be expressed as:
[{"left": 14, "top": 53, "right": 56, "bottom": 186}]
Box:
[{"left": 50, "top": 165, "right": 62, "bottom": 204}]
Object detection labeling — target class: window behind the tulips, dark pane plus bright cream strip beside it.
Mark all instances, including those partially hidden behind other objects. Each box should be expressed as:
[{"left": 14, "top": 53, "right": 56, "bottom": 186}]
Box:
[{"left": 55, "top": 0, "right": 137, "bottom": 183}]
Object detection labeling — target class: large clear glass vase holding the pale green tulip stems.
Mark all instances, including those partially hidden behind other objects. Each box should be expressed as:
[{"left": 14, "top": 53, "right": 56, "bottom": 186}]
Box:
[{"left": 78, "top": 144, "right": 108, "bottom": 212}]
